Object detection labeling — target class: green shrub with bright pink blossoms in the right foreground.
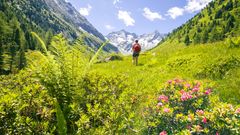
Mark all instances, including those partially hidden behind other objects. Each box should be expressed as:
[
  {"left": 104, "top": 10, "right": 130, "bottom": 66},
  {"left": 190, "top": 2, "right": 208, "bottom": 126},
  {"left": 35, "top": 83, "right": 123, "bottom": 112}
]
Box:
[{"left": 147, "top": 79, "right": 240, "bottom": 135}]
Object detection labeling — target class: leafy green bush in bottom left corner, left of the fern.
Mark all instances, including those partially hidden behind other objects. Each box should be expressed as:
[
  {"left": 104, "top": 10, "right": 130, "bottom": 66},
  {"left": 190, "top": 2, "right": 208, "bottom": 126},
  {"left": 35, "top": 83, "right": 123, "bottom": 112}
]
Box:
[{"left": 0, "top": 71, "right": 56, "bottom": 134}]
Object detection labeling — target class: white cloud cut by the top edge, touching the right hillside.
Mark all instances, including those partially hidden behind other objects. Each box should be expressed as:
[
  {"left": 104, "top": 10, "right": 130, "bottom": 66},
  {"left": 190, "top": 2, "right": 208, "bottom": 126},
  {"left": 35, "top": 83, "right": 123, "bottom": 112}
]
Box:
[{"left": 184, "top": 0, "right": 212, "bottom": 13}]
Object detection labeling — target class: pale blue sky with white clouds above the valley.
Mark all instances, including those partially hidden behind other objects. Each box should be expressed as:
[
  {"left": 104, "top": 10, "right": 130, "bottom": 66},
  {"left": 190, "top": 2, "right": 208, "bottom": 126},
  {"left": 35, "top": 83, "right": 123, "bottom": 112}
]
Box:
[{"left": 66, "top": 0, "right": 211, "bottom": 35}]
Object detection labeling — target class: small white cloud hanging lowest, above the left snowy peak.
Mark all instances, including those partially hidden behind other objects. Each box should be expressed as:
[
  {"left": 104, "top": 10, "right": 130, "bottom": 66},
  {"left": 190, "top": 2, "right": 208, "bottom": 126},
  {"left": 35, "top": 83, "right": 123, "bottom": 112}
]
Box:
[{"left": 118, "top": 10, "right": 135, "bottom": 26}]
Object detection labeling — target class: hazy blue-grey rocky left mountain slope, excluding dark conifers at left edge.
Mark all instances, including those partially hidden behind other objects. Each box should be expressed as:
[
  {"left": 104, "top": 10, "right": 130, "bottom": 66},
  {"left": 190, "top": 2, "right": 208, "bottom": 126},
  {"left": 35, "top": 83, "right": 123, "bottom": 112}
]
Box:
[{"left": 4, "top": 0, "right": 117, "bottom": 52}]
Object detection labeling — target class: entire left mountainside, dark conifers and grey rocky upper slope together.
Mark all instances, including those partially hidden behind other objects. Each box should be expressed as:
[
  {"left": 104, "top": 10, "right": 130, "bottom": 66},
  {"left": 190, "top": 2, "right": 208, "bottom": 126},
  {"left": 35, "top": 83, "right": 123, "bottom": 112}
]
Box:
[{"left": 0, "top": 0, "right": 118, "bottom": 74}]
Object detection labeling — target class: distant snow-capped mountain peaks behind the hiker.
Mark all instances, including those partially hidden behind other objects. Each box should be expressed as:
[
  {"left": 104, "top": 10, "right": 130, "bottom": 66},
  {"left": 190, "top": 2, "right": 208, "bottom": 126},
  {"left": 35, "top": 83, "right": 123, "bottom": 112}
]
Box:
[{"left": 106, "top": 30, "right": 166, "bottom": 54}]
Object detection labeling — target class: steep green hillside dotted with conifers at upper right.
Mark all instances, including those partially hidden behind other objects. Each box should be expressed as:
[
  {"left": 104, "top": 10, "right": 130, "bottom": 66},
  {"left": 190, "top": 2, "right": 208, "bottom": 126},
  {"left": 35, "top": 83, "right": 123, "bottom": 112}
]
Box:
[{"left": 164, "top": 0, "right": 240, "bottom": 45}]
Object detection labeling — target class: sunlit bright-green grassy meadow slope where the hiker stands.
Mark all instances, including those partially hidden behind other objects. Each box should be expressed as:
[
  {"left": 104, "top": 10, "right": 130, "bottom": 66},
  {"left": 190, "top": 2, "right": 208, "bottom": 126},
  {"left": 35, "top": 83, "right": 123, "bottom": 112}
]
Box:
[{"left": 93, "top": 39, "right": 240, "bottom": 103}]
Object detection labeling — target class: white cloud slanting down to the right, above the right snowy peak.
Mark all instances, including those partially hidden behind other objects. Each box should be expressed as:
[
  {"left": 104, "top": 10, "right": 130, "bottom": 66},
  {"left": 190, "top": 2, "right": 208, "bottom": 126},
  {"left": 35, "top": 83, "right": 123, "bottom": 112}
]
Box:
[{"left": 143, "top": 7, "right": 164, "bottom": 21}]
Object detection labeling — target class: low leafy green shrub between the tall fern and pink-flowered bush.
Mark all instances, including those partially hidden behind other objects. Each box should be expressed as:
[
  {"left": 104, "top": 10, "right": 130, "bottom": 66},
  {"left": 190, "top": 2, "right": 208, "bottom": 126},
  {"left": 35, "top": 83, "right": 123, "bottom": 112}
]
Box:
[{"left": 77, "top": 74, "right": 137, "bottom": 134}]
